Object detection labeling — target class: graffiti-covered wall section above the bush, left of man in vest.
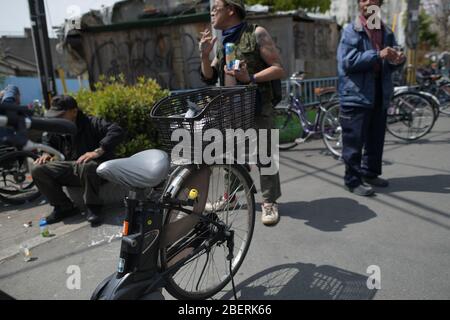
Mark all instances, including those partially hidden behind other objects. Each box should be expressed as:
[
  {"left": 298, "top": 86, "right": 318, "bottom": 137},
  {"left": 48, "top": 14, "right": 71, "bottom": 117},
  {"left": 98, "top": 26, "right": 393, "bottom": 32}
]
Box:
[{"left": 82, "top": 23, "right": 209, "bottom": 89}]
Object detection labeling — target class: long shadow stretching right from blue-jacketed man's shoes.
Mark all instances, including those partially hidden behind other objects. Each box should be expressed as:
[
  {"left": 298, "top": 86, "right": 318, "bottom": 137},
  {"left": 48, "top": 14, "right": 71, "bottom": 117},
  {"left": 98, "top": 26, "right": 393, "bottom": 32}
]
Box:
[{"left": 378, "top": 174, "right": 450, "bottom": 193}]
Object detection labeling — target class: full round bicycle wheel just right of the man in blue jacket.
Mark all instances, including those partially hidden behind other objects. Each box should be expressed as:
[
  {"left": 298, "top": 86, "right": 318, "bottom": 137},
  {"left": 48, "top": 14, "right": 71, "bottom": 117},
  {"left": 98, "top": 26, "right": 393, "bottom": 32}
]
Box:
[{"left": 386, "top": 92, "right": 436, "bottom": 141}]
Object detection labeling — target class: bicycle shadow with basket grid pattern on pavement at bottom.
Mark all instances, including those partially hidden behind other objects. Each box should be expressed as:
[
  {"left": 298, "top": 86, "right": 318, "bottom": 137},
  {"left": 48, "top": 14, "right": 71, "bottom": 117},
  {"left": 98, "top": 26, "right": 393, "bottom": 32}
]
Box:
[{"left": 222, "top": 263, "right": 377, "bottom": 300}]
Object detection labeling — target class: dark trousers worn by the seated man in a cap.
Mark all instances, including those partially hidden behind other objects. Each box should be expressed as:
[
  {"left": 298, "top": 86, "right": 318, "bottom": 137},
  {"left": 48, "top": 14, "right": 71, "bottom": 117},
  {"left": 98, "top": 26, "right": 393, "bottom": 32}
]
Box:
[{"left": 31, "top": 161, "right": 103, "bottom": 207}]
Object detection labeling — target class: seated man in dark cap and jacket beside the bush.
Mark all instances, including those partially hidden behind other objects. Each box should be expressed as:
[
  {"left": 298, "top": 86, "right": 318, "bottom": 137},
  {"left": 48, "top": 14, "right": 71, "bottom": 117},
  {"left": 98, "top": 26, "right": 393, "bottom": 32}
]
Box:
[{"left": 32, "top": 96, "right": 124, "bottom": 225}]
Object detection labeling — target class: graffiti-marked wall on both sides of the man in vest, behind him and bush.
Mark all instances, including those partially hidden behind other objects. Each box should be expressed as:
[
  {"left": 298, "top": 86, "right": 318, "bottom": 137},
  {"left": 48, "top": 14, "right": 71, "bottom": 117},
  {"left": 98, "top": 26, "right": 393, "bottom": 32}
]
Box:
[{"left": 81, "top": 16, "right": 338, "bottom": 90}]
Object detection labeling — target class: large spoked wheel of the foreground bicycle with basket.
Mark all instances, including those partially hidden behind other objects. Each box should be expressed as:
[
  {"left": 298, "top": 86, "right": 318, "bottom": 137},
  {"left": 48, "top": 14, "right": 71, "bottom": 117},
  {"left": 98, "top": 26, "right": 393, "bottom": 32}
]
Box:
[{"left": 160, "top": 165, "right": 255, "bottom": 299}]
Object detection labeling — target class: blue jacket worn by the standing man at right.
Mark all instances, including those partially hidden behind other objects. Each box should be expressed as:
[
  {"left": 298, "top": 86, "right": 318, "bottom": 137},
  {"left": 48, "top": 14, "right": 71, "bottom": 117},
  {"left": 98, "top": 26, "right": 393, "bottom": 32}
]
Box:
[{"left": 337, "top": 17, "right": 403, "bottom": 109}]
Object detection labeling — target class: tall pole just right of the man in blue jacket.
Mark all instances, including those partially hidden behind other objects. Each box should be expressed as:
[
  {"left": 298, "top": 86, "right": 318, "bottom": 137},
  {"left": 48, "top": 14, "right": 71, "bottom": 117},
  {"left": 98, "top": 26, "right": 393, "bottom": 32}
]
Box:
[{"left": 406, "top": 0, "right": 420, "bottom": 85}]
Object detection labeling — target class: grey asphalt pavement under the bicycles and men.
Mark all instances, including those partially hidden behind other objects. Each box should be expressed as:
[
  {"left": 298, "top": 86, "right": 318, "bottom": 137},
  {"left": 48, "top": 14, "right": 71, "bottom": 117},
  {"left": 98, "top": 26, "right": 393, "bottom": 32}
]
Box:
[{"left": 0, "top": 117, "right": 450, "bottom": 300}]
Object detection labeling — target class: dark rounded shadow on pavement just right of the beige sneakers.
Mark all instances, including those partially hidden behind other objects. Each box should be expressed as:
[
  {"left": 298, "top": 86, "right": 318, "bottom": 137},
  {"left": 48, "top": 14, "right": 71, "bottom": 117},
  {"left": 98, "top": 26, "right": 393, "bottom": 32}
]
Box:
[{"left": 279, "top": 198, "right": 377, "bottom": 232}]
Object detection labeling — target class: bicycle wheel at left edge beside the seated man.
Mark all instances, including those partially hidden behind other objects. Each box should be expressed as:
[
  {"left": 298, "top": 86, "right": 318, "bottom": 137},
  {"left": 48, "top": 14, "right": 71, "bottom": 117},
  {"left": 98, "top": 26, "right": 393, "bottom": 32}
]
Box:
[{"left": 0, "top": 151, "right": 41, "bottom": 205}]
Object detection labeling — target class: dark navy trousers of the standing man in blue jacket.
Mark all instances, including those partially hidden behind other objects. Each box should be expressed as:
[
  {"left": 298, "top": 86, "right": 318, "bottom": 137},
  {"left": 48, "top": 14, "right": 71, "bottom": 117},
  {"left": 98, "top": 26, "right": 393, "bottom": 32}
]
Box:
[{"left": 340, "top": 82, "right": 387, "bottom": 188}]
